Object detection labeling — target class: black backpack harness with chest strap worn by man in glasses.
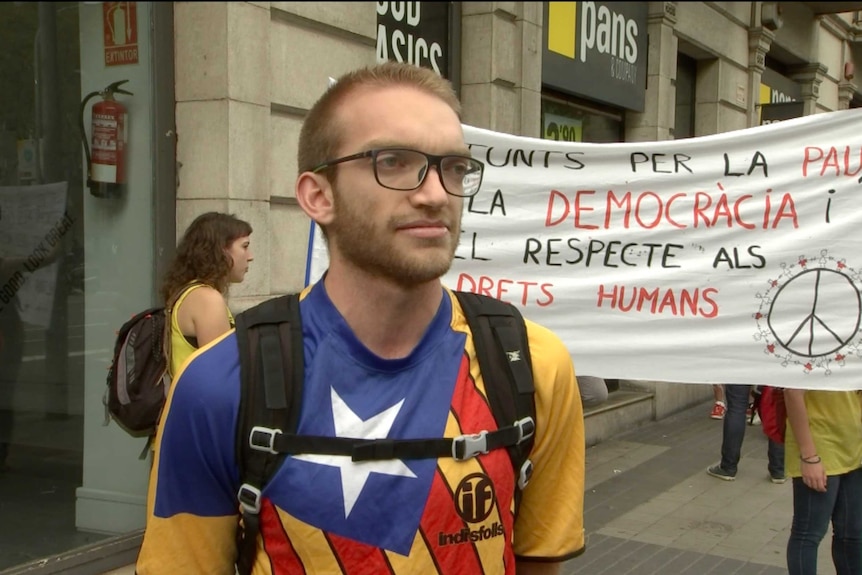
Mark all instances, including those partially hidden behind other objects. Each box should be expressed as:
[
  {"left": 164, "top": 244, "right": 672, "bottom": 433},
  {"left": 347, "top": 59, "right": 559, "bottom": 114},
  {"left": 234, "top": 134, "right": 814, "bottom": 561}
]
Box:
[{"left": 236, "top": 291, "right": 536, "bottom": 575}]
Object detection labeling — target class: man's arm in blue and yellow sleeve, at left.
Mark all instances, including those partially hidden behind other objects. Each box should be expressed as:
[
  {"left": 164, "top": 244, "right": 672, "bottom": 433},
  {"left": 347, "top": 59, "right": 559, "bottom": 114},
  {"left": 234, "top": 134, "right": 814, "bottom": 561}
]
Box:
[{"left": 136, "top": 337, "right": 239, "bottom": 575}]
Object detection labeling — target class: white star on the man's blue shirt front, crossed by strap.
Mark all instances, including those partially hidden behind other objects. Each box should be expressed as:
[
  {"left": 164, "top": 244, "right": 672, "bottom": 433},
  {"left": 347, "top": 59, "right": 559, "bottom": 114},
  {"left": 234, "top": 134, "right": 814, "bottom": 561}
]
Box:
[{"left": 294, "top": 389, "right": 416, "bottom": 519}]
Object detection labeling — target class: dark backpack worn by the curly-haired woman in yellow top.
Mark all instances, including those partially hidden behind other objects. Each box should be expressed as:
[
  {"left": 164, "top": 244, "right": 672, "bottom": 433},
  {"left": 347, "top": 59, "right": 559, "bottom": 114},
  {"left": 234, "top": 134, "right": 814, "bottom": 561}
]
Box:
[{"left": 102, "top": 282, "right": 197, "bottom": 440}]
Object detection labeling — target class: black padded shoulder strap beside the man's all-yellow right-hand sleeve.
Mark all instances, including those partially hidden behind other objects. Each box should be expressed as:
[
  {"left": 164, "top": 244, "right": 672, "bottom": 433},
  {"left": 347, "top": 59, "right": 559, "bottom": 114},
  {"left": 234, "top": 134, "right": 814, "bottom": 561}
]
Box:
[{"left": 454, "top": 291, "right": 536, "bottom": 502}]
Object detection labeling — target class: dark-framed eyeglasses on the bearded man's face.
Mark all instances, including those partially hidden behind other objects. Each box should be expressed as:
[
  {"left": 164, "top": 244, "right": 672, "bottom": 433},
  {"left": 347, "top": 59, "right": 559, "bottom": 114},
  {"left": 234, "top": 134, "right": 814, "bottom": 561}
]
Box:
[{"left": 311, "top": 148, "right": 485, "bottom": 198}]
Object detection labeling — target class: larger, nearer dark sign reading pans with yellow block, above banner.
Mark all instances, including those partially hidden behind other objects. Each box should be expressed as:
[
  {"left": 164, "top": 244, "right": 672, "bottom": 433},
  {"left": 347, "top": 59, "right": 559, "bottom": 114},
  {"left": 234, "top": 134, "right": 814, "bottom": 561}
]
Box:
[{"left": 542, "top": 2, "right": 648, "bottom": 112}]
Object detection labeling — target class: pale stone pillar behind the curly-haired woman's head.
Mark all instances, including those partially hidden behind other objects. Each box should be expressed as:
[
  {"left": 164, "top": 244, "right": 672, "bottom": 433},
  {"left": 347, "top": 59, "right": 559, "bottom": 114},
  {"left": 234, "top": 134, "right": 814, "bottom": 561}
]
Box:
[{"left": 174, "top": 2, "right": 273, "bottom": 311}]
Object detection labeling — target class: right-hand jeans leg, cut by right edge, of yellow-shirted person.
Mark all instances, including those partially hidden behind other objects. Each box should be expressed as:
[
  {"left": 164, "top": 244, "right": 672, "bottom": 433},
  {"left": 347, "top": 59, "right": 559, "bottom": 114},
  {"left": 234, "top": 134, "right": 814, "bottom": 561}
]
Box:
[{"left": 829, "top": 468, "right": 862, "bottom": 575}]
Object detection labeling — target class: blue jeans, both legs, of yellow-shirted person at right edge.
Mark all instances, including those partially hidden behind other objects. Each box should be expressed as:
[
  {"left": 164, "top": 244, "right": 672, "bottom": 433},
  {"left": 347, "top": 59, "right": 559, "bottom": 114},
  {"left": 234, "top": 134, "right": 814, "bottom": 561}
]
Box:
[{"left": 787, "top": 468, "right": 862, "bottom": 575}]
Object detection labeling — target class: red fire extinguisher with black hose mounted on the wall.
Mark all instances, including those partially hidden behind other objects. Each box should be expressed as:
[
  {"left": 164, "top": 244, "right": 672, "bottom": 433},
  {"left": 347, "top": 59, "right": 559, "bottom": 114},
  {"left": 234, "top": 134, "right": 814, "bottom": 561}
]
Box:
[{"left": 80, "top": 80, "right": 132, "bottom": 198}]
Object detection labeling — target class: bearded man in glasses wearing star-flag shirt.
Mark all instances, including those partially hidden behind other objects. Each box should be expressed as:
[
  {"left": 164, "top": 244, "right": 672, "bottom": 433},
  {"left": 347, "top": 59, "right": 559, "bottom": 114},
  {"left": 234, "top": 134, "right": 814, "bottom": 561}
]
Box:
[{"left": 137, "top": 63, "right": 584, "bottom": 575}]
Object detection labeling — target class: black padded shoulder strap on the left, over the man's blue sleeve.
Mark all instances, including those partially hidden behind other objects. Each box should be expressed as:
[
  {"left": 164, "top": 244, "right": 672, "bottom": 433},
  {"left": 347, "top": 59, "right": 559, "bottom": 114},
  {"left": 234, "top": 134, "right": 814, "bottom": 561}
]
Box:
[{"left": 236, "top": 294, "right": 304, "bottom": 575}]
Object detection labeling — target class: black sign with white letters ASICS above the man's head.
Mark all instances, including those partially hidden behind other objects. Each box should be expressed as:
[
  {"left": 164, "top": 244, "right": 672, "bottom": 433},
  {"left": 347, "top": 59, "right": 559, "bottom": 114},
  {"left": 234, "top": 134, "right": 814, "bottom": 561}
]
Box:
[{"left": 377, "top": 2, "right": 449, "bottom": 78}]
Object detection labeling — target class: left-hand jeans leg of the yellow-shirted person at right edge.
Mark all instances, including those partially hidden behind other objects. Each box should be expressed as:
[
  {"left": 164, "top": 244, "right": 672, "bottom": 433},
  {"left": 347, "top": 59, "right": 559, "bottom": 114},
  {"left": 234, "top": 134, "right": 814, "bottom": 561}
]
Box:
[{"left": 787, "top": 477, "right": 838, "bottom": 575}]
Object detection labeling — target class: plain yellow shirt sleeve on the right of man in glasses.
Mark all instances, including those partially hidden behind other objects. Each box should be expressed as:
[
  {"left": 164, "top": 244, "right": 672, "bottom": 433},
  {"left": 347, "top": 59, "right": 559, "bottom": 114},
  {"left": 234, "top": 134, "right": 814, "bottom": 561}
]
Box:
[{"left": 514, "top": 320, "right": 585, "bottom": 561}]
